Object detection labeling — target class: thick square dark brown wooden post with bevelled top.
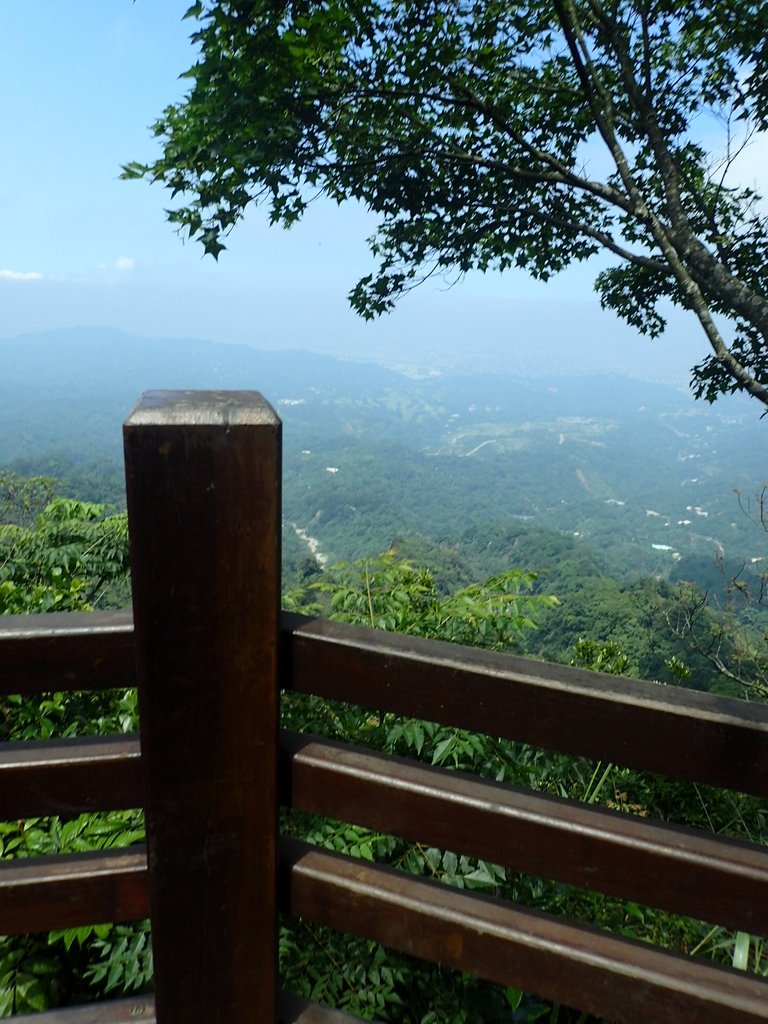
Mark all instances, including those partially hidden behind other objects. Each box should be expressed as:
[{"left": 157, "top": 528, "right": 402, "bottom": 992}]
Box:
[{"left": 124, "top": 391, "right": 281, "bottom": 1024}]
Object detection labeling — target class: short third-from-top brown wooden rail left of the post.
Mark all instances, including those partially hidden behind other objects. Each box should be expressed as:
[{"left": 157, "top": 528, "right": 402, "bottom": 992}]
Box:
[{"left": 0, "top": 847, "right": 150, "bottom": 935}]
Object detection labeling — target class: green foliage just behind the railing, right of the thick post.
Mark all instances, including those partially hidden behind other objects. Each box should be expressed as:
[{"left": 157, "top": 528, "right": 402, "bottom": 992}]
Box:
[{"left": 281, "top": 551, "right": 768, "bottom": 1024}]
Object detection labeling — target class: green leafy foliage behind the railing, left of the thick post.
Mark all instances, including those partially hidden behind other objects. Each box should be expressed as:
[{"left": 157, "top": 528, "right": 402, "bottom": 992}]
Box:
[{"left": 0, "top": 473, "right": 143, "bottom": 1016}]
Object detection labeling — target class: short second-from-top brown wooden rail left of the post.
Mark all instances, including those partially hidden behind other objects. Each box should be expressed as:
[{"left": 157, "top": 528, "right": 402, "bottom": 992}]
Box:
[{"left": 0, "top": 736, "right": 143, "bottom": 821}]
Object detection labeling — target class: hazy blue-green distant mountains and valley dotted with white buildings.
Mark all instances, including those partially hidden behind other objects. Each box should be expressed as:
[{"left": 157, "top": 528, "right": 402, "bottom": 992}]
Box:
[{"left": 0, "top": 329, "right": 768, "bottom": 575}]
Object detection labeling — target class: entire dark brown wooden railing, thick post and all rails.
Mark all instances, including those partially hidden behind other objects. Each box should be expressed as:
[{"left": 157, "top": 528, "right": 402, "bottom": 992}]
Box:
[{"left": 0, "top": 394, "right": 768, "bottom": 1024}]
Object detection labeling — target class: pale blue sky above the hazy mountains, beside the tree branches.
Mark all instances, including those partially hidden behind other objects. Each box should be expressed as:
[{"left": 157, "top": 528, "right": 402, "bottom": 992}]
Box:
[{"left": 0, "top": 0, "right": 760, "bottom": 383}]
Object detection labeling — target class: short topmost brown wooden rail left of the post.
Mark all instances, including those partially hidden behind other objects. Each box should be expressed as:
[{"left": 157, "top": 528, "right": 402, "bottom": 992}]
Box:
[{"left": 0, "top": 611, "right": 135, "bottom": 693}]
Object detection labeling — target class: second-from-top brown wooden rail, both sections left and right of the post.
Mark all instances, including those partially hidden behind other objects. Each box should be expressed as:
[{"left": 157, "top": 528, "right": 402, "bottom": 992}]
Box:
[{"left": 6, "top": 712, "right": 768, "bottom": 934}]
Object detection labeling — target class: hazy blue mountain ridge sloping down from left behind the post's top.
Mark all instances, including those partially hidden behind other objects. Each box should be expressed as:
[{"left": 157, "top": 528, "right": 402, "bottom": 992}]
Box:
[{"left": 0, "top": 328, "right": 400, "bottom": 465}]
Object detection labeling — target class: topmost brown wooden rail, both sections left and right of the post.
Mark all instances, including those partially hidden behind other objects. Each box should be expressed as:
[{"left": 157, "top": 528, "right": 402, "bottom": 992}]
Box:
[{"left": 6, "top": 612, "right": 768, "bottom": 797}]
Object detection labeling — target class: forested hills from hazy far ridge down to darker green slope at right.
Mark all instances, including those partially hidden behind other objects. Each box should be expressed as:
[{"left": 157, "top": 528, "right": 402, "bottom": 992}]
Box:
[{"left": 0, "top": 331, "right": 765, "bottom": 688}]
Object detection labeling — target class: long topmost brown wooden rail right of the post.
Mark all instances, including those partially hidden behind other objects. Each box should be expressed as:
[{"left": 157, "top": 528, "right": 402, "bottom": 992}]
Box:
[{"left": 283, "top": 615, "right": 768, "bottom": 796}]
